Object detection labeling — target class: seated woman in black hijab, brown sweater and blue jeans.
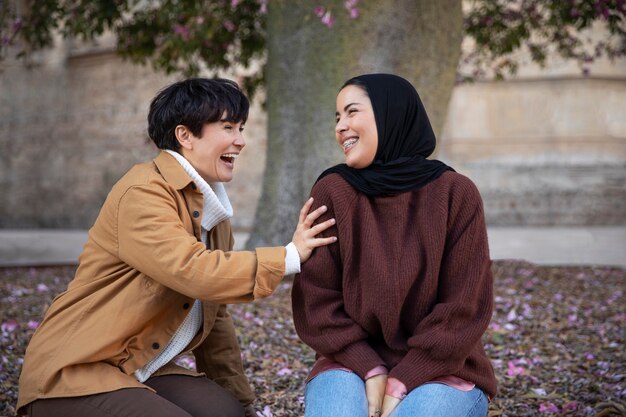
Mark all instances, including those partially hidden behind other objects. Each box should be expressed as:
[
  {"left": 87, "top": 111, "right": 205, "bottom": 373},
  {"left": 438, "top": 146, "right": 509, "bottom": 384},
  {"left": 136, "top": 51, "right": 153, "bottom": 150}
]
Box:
[{"left": 292, "top": 74, "right": 496, "bottom": 417}]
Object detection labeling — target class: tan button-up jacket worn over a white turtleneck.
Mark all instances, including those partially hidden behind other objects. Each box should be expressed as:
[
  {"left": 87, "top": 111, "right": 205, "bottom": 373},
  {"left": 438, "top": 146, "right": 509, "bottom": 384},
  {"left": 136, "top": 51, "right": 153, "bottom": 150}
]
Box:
[{"left": 17, "top": 152, "right": 285, "bottom": 413}]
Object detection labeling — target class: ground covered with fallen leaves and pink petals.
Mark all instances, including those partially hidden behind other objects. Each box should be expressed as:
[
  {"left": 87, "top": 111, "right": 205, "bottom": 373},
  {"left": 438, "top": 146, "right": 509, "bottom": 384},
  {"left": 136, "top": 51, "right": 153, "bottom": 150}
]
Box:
[{"left": 0, "top": 261, "right": 626, "bottom": 417}]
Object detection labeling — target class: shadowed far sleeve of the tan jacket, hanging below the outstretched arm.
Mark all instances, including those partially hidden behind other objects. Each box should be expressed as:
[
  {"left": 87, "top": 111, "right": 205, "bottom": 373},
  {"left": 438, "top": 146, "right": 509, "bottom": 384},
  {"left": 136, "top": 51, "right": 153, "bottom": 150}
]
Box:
[{"left": 193, "top": 305, "right": 254, "bottom": 406}]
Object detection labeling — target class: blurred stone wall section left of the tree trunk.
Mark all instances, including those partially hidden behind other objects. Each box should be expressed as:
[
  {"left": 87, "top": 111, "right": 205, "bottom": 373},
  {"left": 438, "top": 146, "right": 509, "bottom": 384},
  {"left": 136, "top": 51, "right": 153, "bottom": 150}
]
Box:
[{"left": 0, "top": 38, "right": 265, "bottom": 229}]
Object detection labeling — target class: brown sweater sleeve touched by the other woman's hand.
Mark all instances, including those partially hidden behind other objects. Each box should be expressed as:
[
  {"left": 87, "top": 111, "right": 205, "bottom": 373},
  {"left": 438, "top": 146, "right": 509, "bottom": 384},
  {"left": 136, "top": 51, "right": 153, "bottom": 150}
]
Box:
[{"left": 292, "top": 181, "right": 385, "bottom": 379}]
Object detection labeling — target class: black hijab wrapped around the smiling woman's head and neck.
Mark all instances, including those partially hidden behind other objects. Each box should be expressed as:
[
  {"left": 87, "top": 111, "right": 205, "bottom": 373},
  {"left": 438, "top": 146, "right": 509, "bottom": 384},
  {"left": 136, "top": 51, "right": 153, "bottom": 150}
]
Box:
[{"left": 317, "top": 74, "right": 454, "bottom": 196}]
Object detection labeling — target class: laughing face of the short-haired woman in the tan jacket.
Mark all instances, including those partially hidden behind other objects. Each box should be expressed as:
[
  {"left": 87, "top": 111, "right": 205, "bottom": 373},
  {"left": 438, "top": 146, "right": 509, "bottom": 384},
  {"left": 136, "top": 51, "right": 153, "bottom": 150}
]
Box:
[{"left": 176, "top": 117, "right": 246, "bottom": 183}]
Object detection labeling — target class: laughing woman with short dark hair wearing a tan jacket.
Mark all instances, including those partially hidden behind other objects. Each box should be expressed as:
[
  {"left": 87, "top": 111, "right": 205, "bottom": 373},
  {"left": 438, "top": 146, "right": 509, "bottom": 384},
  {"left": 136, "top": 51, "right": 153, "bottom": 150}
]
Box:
[{"left": 17, "top": 78, "right": 333, "bottom": 417}]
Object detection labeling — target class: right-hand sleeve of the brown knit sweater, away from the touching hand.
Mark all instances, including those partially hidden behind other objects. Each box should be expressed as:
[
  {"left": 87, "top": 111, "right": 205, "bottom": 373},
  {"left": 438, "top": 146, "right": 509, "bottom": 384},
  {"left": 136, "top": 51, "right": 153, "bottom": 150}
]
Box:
[{"left": 389, "top": 179, "right": 493, "bottom": 392}]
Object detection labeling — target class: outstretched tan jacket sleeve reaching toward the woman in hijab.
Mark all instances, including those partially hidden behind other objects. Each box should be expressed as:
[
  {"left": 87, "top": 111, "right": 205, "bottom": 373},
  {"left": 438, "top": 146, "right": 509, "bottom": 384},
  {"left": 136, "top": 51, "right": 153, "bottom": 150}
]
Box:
[{"left": 116, "top": 184, "right": 285, "bottom": 303}]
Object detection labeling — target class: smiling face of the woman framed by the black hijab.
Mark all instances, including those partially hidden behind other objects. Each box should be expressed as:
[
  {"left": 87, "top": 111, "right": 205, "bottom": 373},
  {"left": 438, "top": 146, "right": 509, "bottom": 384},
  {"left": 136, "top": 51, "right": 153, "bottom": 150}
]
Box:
[{"left": 335, "top": 85, "right": 378, "bottom": 169}]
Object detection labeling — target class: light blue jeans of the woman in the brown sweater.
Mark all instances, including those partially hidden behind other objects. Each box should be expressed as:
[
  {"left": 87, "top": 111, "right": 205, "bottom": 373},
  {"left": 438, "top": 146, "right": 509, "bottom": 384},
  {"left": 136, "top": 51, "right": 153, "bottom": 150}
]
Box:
[{"left": 304, "top": 370, "right": 489, "bottom": 417}]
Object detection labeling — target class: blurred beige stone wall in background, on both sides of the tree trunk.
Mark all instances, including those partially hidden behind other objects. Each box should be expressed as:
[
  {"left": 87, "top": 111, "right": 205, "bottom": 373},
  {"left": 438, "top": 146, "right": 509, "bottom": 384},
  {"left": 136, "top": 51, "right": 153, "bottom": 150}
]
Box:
[{"left": 0, "top": 35, "right": 626, "bottom": 230}]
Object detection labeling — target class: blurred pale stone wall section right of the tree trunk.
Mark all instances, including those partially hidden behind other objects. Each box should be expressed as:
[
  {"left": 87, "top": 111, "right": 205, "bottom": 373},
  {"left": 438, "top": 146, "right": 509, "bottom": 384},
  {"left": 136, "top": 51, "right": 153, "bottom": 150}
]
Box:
[{"left": 439, "top": 61, "right": 626, "bottom": 225}]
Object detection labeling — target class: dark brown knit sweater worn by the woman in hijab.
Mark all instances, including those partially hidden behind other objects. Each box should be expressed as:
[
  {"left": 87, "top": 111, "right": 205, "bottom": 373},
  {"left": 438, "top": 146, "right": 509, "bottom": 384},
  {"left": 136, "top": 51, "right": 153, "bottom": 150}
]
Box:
[{"left": 292, "top": 171, "right": 496, "bottom": 398}]
